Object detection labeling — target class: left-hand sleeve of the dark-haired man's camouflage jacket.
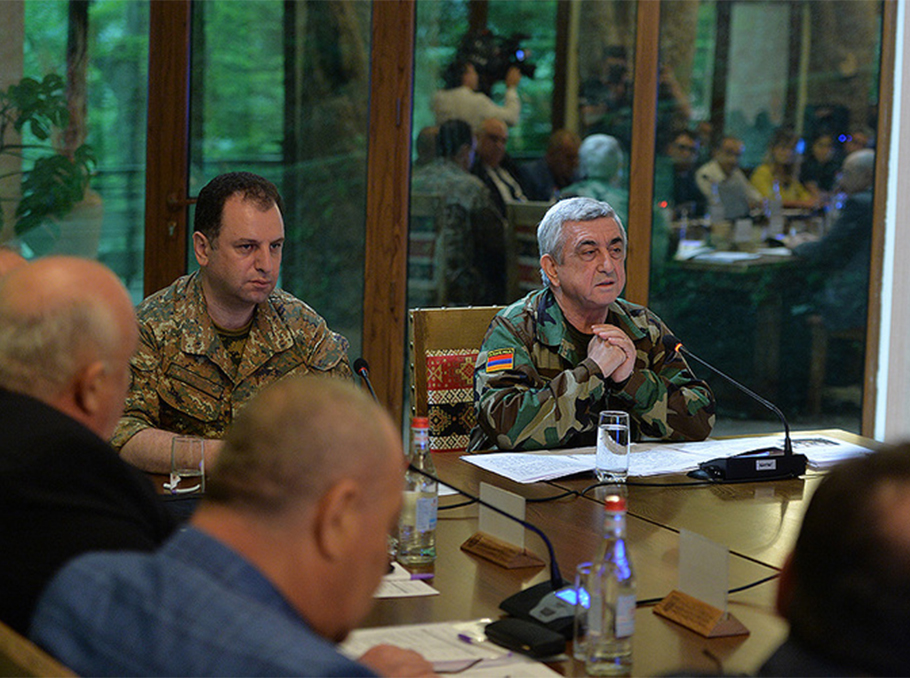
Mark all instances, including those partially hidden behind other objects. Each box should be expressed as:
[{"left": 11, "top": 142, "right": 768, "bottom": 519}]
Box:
[{"left": 111, "top": 327, "right": 161, "bottom": 452}]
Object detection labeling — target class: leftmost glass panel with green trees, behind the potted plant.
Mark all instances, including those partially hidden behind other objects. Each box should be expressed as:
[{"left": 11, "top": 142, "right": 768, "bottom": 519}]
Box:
[{"left": 0, "top": 0, "right": 148, "bottom": 301}]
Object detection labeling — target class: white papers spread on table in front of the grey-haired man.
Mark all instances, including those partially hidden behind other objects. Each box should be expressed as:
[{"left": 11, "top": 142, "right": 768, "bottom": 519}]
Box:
[{"left": 461, "top": 434, "right": 872, "bottom": 483}]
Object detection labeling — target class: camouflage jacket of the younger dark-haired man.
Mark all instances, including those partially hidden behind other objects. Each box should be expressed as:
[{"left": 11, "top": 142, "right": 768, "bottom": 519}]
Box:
[{"left": 111, "top": 273, "right": 353, "bottom": 450}]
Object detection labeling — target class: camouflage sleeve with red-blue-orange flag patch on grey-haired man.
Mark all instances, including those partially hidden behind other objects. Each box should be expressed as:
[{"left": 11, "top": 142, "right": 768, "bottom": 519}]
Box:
[{"left": 472, "top": 316, "right": 606, "bottom": 450}]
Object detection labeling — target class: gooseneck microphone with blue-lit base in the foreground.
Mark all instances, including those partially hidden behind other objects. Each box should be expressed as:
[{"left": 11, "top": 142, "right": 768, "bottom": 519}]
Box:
[{"left": 408, "top": 464, "right": 575, "bottom": 639}]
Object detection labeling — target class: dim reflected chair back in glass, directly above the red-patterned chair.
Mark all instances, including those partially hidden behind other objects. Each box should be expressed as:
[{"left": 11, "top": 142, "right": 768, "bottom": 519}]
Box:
[{"left": 408, "top": 193, "right": 446, "bottom": 307}]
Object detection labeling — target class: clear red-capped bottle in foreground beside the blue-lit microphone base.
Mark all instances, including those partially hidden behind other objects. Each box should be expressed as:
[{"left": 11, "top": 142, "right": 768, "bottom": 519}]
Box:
[{"left": 585, "top": 495, "right": 635, "bottom": 676}]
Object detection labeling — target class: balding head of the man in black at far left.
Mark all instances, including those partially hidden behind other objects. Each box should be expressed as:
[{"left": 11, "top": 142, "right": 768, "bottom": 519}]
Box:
[{"left": 0, "top": 257, "right": 138, "bottom": 438}]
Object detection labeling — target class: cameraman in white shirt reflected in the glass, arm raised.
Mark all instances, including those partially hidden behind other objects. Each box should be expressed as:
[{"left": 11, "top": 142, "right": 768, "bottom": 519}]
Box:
[{"left": 431, "top": 59, "right": 521, "bottom": 132}]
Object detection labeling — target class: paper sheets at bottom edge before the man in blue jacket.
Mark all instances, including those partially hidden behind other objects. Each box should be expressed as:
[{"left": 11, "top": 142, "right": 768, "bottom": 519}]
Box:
[{"left": 339, "top": 619, "right": 559, "bottom": 677}]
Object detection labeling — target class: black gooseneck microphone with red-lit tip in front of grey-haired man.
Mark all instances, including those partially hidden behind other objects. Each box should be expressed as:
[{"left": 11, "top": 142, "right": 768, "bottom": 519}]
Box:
[{"left": 663, "top": 334, "right": 806, "bottom": 482}]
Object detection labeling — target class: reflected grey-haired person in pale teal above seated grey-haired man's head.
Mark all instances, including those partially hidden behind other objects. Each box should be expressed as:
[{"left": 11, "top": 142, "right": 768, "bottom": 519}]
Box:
[{"left": 563, "top": 134, "right": 670, "bottom": 274}]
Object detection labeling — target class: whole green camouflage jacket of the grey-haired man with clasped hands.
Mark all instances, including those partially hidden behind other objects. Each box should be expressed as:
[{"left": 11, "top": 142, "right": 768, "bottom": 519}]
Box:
[{"left": 468, "top": 289, "right": 714, "bottom": 451}]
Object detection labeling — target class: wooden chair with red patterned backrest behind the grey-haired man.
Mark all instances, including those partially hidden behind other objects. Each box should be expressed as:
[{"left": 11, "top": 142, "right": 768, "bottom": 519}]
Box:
[{"left": 409, "top": 306, "right": 503, "bottom": 452}]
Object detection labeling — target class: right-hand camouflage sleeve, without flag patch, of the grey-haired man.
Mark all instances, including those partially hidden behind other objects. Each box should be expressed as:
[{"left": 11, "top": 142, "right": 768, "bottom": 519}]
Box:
[{"left": 612, "top": 312, "right": 715, "bottom": 441}]
